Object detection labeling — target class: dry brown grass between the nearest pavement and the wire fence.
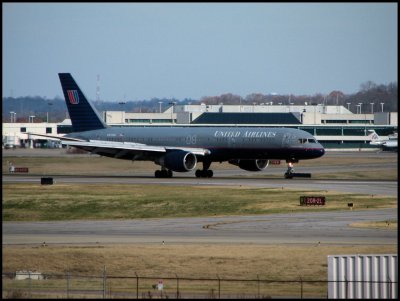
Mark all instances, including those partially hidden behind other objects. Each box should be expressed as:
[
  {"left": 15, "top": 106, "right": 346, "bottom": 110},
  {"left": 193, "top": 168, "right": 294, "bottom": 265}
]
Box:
[{"left": 3, "top": 244, "right": 397, "bottom": 280}]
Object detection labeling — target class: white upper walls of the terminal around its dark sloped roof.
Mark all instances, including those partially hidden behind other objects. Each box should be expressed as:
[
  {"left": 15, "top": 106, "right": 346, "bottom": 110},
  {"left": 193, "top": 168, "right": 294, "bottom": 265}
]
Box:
[{"left": 103, "top": 104, "right": 397, "bottom": 126}]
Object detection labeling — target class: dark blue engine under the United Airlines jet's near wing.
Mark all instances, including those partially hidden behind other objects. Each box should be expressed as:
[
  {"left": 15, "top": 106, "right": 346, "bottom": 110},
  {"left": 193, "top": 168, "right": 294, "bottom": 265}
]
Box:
[{"left": 157, "top": 150, "right": 197, "bottom": 172}]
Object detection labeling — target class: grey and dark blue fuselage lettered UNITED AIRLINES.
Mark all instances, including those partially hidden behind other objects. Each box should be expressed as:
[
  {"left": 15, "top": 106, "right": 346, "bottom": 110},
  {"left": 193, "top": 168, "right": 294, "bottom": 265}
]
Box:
[{"left": 68, "top": 126, "right": 325, "bottom": 162}]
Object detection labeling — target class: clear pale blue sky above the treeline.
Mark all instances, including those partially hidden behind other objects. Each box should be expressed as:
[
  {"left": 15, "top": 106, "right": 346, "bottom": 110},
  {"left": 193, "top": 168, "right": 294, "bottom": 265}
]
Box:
[{"left": 2, "top": 2, "right": 398, "bottom": 102}]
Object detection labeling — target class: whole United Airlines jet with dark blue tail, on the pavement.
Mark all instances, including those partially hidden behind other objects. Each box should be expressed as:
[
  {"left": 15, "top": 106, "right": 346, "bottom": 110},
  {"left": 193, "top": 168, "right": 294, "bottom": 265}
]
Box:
[{"left": 31, "top": 73, "right": 325, "bottom": 178}]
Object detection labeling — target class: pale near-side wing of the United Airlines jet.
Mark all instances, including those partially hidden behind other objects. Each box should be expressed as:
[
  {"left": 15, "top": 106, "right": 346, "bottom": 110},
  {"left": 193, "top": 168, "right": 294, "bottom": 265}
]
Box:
[{"left": 62, "top": 140, "right": 210, "bottom": 160}]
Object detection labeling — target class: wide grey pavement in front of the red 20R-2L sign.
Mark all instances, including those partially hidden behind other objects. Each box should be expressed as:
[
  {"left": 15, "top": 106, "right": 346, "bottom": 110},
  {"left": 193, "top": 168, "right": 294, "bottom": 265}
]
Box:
[{"left": 3, "top": 209, "right": 397, "bottom": 246}]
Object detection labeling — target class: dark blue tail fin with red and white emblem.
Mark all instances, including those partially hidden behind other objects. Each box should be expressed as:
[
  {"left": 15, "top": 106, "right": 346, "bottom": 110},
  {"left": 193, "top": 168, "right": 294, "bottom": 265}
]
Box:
[{"left": 58, "top": 73, "right": 107, "bottom": 132}]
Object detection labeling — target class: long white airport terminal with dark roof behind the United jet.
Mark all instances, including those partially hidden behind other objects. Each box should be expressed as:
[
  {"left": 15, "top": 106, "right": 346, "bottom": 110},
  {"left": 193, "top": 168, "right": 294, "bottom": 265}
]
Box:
[{"left": 2, "top": 104, "right": 398, "bottom": 150}]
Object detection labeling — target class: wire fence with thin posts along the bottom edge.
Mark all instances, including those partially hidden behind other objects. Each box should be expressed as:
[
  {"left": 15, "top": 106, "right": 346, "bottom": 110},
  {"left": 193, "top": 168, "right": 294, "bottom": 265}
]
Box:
[{"left": 2, "top": 269, "right": 397, "bottom": 299}]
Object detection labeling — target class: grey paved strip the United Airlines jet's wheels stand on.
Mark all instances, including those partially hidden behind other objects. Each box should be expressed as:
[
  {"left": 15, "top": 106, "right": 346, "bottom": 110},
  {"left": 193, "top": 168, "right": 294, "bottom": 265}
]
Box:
[{"left": 3, "top": 171, "right": 398, "bottom": 196}]
